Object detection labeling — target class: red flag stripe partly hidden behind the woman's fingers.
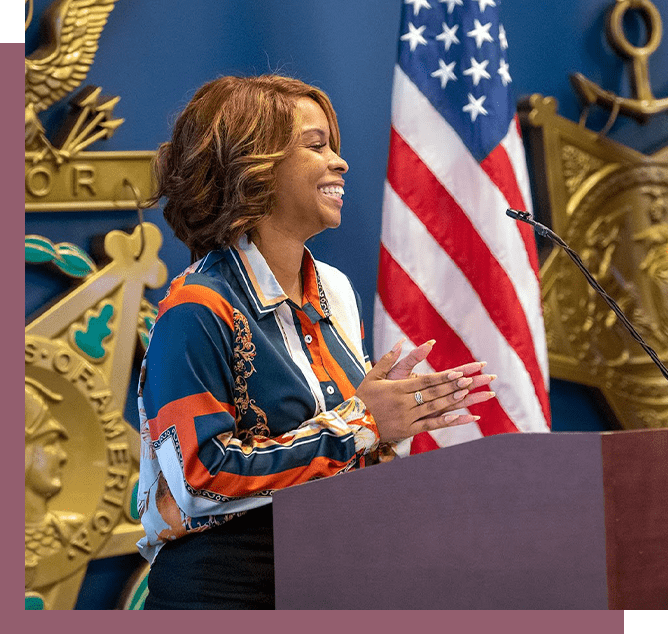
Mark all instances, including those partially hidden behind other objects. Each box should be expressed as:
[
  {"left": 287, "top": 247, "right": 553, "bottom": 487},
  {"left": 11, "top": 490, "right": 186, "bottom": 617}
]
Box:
[{"left": 378, "top": 243, "right": 518, "bottom": 436}]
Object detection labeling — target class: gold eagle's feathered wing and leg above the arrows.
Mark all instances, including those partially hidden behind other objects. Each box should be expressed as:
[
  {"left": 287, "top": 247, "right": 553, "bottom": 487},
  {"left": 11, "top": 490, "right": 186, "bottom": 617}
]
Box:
[{"left": 25, "top": 0, "right": 117, "bottom": 149}]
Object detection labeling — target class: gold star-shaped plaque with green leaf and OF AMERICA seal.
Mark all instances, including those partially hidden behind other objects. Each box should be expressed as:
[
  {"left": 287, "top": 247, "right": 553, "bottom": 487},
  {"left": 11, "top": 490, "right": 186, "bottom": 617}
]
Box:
[{"left": 25, "top": 223, "right": 167, "bottom": 609}]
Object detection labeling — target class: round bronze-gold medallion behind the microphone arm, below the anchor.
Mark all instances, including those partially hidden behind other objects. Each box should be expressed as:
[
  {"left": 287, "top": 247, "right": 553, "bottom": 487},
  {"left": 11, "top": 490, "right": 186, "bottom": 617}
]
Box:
[{"left": 559, "top": 164, "right": 668, "bottom": 360}]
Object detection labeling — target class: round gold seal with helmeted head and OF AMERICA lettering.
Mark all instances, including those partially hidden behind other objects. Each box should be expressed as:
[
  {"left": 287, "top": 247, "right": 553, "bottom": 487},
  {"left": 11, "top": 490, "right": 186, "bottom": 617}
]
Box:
[{"left": 25, "top": 336, "right": 131, "bottom": 589}]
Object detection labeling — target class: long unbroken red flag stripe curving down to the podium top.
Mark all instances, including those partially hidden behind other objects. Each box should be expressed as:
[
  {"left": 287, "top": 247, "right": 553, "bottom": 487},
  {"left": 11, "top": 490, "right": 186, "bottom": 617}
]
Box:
[{"left": 387, "top": 128, "right": 550, "bottom": 420}]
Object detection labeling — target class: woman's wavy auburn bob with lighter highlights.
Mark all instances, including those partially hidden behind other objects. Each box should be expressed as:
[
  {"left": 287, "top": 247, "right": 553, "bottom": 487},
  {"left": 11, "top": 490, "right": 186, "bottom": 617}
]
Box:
[{"left": 146, "top": 75, "right": 340, "bottom": 259}]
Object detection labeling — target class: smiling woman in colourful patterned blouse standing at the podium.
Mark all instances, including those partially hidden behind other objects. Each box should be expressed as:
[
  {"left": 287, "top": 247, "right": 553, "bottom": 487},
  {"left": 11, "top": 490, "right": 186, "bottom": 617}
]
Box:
[{"left": 138, "top": 75, "right": 494, "bottom": 609}]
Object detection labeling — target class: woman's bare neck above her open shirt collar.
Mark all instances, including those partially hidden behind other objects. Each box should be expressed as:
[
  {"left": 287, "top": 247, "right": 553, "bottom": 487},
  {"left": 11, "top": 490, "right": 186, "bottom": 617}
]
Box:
[{"left": 251, "top": 223, "right": 304, "bottom": 306}]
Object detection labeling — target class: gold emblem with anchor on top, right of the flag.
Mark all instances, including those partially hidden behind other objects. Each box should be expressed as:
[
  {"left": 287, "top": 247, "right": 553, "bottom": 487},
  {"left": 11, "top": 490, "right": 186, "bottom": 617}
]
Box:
[{"left": 520, "top": 0, "right": 668, "bottom": 429}]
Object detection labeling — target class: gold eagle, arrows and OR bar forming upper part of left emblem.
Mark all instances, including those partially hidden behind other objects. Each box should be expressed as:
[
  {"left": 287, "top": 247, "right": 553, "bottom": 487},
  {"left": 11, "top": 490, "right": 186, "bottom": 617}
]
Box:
[{"left": 25, "top": 0, "right": 155, "bottom": 211}]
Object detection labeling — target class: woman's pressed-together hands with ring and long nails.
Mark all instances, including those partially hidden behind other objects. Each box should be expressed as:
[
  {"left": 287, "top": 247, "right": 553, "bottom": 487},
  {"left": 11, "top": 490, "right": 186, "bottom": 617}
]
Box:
[{"left": 356, "top": 340, "right": 496, "bottom": 442}]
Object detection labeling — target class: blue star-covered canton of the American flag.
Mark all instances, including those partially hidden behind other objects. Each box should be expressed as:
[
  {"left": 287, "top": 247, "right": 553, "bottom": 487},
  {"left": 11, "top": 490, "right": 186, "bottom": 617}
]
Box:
[{"left": 398, "top": 0, "right": 515, "bottom": 162}]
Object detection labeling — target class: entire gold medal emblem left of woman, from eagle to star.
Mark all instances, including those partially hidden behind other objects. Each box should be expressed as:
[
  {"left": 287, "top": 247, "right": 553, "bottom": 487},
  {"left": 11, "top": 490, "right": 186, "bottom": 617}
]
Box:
[{"left": 25, "top": 0, "right": 167, "bottom": 609}]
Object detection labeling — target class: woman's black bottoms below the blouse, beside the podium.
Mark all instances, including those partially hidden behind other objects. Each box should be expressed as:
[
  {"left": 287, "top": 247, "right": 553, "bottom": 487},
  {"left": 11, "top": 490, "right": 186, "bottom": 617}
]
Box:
[{"left": 144, "top": 504, "right": 275, "bottom": 610}]
